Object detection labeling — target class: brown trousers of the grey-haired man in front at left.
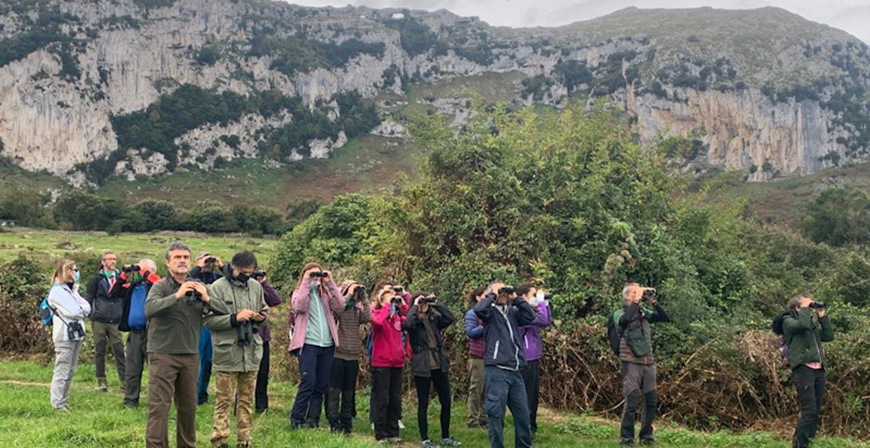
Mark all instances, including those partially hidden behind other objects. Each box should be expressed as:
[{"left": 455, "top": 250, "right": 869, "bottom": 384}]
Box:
[{"left": 145, "top": 353, "right": 197, "bottom": 448}]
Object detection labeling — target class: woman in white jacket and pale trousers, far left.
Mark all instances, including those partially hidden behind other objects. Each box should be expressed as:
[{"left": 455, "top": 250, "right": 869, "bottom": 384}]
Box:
[{"left": 48, "top": 260, "right": 91, "bottom": 411}]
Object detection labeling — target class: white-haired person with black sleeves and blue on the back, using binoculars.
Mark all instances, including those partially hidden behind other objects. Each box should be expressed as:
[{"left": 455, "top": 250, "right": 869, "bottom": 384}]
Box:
[{"left": 113, "top": 259, "right": 160, "bottom": 408}]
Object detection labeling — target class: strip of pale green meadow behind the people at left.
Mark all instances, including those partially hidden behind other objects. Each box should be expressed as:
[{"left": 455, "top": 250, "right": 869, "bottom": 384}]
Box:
[{"left": 0, "top": 229, "right": 277, "bottom": 265}]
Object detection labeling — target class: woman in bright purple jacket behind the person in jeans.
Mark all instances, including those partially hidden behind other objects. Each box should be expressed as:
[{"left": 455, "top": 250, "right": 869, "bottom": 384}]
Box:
[{"left": 517, "top": 283, "right": 553, "bottom": 438}]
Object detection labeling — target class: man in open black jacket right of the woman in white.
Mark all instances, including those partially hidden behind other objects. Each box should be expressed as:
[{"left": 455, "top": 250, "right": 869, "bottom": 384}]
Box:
[{"left": 85, "top": 252, "right": 127, "bottom": 392}]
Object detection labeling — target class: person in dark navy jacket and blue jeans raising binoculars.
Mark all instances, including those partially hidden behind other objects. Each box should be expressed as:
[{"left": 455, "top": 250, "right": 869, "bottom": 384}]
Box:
[{"left": 474, "top": 282, "right": 535, "bottom": 448}]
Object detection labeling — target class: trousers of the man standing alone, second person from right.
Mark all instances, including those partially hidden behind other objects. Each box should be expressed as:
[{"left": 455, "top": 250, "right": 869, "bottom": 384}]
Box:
[{"left": 619, "top": 362, "right": 658, "bottom": 441}]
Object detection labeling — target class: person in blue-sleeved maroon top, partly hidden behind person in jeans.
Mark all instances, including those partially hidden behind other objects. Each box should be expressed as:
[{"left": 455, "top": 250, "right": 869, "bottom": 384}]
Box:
[{"left": 465, "top": 288, "right": 489, "bottom": 428}]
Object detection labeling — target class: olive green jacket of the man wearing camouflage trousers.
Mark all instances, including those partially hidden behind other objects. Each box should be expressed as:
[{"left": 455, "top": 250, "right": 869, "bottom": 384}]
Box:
[{"left": 205, "top": 277, "right": 266, "bottom": 372}]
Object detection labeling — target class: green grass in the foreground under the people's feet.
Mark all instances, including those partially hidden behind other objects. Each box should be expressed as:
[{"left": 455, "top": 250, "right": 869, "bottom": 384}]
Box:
[{"left": 0, "top": 353, "right": 867, "bottom": 448}]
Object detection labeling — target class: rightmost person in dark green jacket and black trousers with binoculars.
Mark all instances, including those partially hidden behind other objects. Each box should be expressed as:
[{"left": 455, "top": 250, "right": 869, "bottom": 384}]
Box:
[{"left": 782, "top": 294, "right": 834, "bottom": 448}]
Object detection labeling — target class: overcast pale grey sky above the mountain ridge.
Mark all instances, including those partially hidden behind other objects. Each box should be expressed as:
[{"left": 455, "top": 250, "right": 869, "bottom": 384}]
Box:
[{"left": 290, "top": 0, "right": 870, "bottom": 42}]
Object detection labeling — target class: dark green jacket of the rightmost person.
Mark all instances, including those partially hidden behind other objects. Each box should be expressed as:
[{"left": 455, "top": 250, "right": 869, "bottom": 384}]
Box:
[{"left": 782, "top": 308, "right": 834, "bottom": 369}]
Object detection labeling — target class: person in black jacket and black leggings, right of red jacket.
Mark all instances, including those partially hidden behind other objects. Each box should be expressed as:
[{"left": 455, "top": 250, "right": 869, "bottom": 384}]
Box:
[{"left": 402, "top": 293, "right": 461, "bottom": 448}]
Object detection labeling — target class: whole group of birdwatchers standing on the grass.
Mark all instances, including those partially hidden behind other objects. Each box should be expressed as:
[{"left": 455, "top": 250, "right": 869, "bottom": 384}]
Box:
[{"left": 42, "top": 243, "right": 833, "bottom": 448}]
